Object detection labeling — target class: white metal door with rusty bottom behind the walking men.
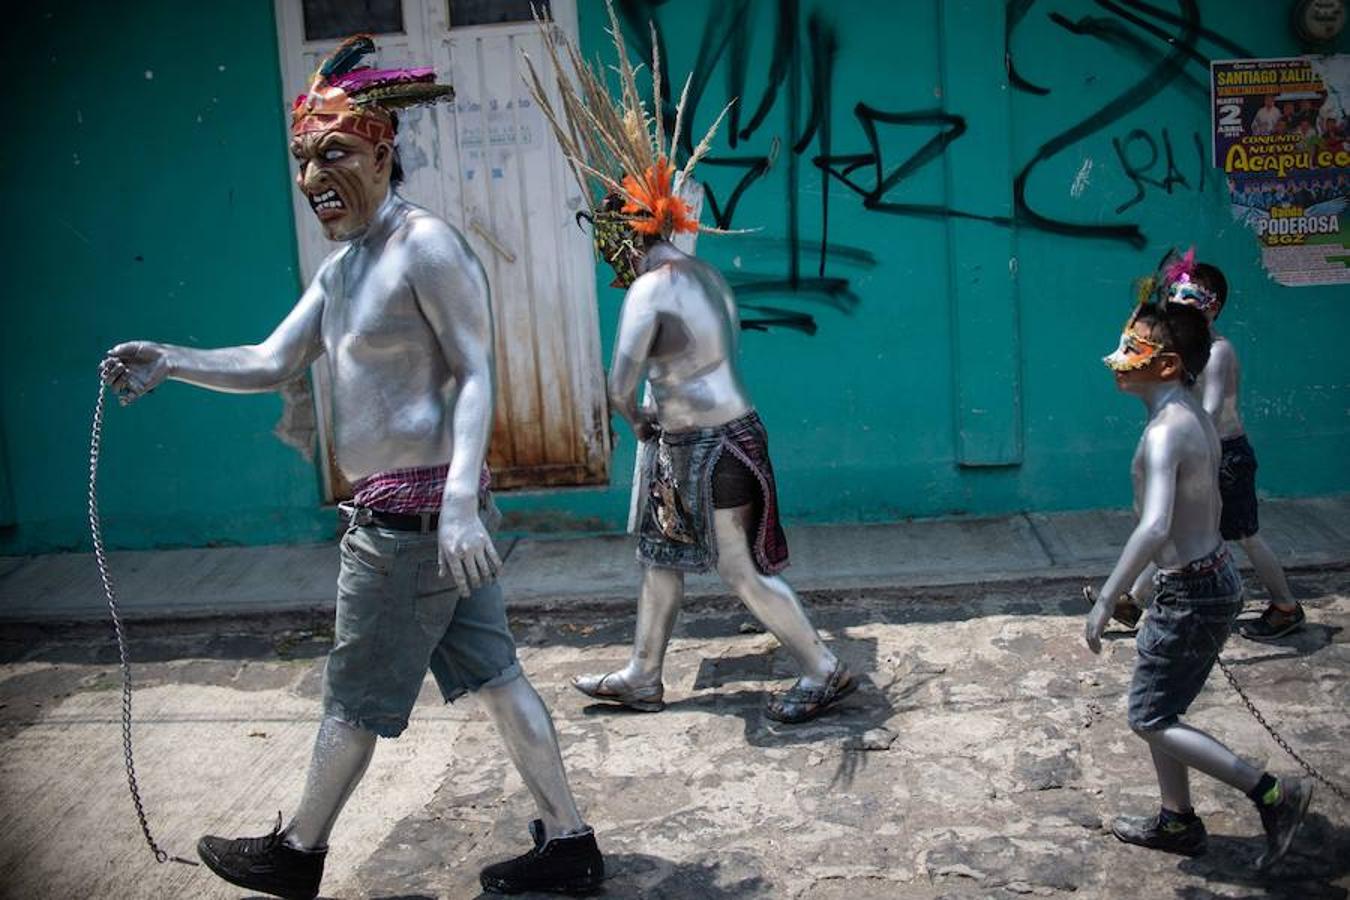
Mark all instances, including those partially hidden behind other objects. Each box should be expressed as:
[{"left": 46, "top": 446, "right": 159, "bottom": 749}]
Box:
[{"left": 277, "top": 0, "right": 609, "bottom": 499}]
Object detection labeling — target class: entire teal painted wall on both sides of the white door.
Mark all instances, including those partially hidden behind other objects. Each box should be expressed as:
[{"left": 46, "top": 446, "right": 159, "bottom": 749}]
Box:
[{"left": 0, "top": 0, "right": 1350, "bottom": 553}]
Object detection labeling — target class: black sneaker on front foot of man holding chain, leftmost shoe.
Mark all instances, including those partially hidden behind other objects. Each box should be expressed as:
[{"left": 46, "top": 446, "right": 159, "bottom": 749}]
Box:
[{"left": 197, "top": 814, "right": 328, "bottom": 900}]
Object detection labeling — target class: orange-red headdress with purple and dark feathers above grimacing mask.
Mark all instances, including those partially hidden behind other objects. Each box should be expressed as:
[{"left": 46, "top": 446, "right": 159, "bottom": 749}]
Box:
[{"left": 290, "top": 34, "right": 455, "bottom": 143}]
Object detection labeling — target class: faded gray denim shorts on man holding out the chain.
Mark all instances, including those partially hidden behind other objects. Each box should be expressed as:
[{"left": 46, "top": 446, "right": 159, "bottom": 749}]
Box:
[{"left": 324, "top": 525, "right": 520, "bottom": 738}]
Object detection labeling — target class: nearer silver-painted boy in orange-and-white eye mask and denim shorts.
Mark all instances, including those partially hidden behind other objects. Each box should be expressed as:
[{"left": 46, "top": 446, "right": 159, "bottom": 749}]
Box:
[{"left": 1085, "top": 304, "right": 1312, "bottom": 869}]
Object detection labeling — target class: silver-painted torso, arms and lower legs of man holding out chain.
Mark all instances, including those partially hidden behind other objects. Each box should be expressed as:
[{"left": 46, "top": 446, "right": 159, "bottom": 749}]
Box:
[{"left": 103, "top": 190, "right": 586, "bottom": 846}]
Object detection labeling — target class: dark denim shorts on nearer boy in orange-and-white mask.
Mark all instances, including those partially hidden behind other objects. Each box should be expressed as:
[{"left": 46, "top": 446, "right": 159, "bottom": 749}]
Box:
[{"left": 1130, "top": 546, "right": 1242, "bottom": 731}]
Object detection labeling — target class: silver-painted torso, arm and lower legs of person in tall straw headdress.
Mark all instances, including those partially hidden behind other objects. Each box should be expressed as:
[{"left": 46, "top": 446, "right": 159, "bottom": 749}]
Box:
[{"left": 596, "top": 242, "right": 838, "bottom": 688}]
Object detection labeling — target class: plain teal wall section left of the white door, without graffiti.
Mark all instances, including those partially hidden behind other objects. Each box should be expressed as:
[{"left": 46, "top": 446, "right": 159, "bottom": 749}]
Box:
[{"left": 0, "top": 0, "right": 332, "bottom": 553}]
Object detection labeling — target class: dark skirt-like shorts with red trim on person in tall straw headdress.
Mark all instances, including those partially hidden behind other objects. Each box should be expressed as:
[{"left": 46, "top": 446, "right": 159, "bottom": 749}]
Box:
[{"left": 637, "top": 412, "right": 787, "bottom": 575}]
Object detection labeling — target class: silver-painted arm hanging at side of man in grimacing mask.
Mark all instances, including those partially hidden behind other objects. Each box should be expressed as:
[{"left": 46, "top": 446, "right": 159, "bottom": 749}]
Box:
[{"left": 408, "top": 219, "right": 501, "bottom": 594}]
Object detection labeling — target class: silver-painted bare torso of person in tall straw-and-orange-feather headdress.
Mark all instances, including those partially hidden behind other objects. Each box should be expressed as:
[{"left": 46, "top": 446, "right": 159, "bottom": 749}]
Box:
[{"left": 610, "top": 244, "right": 752, "bottom": 430}]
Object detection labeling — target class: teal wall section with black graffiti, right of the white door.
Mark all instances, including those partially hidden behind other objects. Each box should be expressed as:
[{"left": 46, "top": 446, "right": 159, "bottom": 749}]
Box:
[{"left": 496, "top": 0, "right": 1350, "bottom": 534}]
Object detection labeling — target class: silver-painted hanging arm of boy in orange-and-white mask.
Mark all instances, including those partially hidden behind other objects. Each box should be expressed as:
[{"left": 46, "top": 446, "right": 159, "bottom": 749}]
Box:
[{"left": 1084, "top": 429, "right": 1180, "bottom": 653}]
